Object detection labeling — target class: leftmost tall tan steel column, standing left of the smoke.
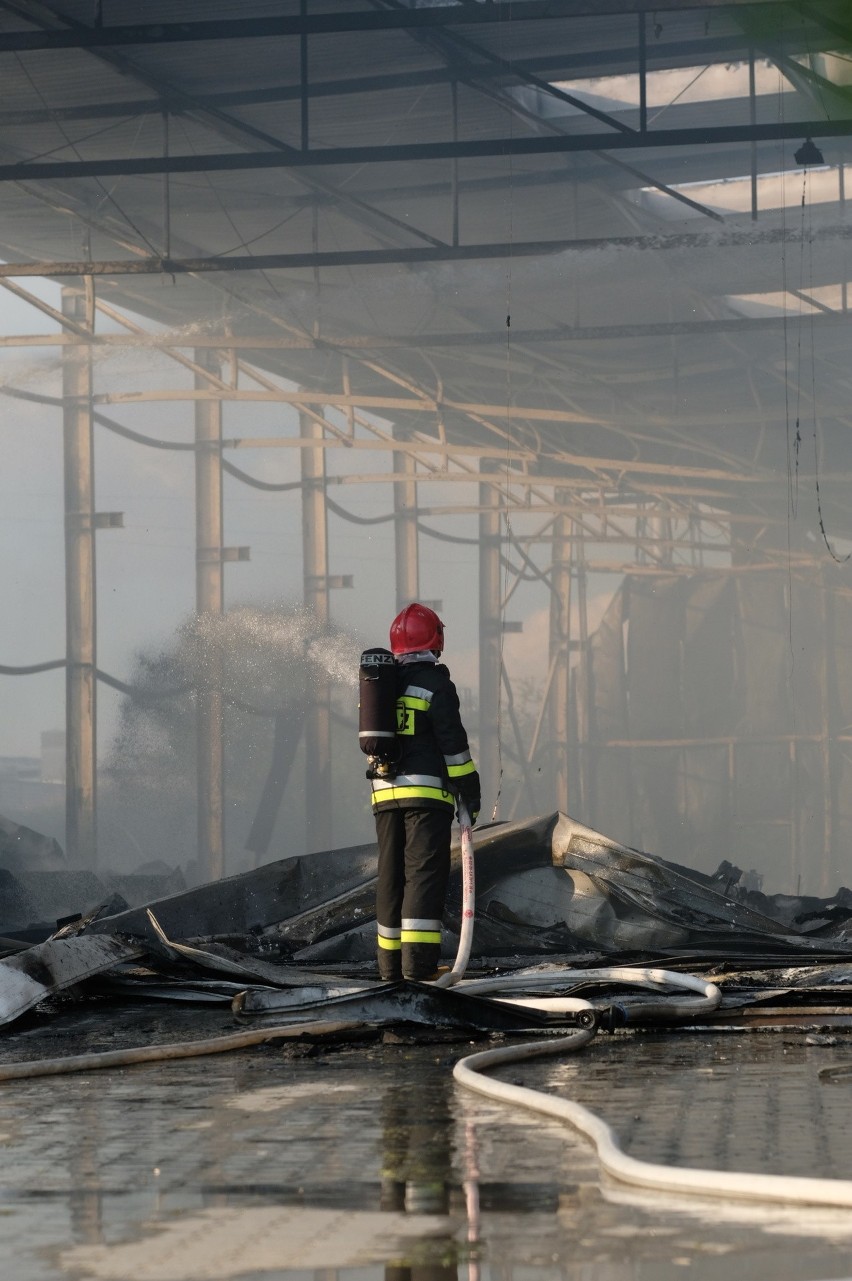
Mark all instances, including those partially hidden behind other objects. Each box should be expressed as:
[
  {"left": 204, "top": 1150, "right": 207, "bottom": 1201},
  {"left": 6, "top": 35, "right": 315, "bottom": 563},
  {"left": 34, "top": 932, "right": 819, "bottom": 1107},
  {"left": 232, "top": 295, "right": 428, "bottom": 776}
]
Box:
[{"left": 61, "top": 277, "right": 97, "bottom": 867}]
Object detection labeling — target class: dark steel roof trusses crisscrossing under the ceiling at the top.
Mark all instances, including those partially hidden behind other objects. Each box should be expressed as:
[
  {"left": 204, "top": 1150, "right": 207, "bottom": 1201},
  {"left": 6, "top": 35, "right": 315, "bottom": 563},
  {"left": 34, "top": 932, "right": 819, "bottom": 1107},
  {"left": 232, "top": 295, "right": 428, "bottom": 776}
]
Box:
[{"left": 0, "top": 0, "right": 852, "bottom": 275}]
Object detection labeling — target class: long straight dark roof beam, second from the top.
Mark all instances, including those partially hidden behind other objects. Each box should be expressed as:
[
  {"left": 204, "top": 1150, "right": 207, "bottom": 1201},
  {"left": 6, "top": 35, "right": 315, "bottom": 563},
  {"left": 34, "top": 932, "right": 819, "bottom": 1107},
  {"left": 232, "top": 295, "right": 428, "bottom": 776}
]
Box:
[{"left": 0, "top": 119, "right": 852, "bottom": 182}]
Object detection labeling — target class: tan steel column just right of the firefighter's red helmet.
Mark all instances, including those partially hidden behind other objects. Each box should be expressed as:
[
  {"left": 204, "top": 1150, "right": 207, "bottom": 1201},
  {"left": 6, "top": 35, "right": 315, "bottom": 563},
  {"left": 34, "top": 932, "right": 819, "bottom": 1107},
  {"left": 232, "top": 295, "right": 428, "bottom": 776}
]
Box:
[{"left": 478, "top": 459, "right": 502, "bottom": 817}]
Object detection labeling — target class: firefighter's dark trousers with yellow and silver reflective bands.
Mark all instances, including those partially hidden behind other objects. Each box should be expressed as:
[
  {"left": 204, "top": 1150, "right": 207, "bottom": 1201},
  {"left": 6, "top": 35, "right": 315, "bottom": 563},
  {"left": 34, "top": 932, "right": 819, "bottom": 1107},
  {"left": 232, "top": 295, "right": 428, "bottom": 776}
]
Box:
[{"left": 375, "top": 806, "right": 454, "bottom": 979}]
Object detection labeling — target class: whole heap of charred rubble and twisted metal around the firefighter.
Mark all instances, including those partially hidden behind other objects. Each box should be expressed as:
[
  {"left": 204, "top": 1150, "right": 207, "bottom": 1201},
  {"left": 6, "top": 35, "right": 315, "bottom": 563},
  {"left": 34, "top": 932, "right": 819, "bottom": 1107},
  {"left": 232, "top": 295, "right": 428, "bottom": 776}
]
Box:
[{"left": 0, "top": 812, "right": 852, "bottom": 1032}]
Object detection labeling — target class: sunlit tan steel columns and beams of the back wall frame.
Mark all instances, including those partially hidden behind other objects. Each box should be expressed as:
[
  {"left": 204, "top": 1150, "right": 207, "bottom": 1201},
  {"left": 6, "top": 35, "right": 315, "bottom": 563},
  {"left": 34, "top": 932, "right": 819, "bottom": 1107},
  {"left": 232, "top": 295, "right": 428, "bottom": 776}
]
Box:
[{"left": 5, "top": 278, "right": 830, "bottom": 877}]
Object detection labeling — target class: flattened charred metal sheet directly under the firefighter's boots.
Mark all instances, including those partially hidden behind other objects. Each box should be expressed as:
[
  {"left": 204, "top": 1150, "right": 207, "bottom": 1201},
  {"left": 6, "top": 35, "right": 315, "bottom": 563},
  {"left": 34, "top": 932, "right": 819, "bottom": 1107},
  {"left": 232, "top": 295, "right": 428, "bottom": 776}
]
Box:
[{"left": 233, "top": 981, "right": 594, "bottom": 1031}]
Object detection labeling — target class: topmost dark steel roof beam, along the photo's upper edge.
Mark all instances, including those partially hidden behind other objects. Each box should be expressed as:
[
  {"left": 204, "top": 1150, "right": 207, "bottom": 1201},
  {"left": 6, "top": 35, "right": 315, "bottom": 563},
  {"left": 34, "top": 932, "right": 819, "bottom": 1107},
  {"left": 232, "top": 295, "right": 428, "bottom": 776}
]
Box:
[{"left": 0, "top": 0, "right": 778, "bottom": 54}]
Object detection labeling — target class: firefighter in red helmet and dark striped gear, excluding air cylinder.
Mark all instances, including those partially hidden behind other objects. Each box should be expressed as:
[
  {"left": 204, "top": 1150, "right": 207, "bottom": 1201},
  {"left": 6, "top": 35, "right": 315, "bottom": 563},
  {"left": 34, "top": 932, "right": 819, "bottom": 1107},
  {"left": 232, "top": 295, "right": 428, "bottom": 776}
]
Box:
[{"left": 368, "top": 603, "right": 479, "bottom": 980}]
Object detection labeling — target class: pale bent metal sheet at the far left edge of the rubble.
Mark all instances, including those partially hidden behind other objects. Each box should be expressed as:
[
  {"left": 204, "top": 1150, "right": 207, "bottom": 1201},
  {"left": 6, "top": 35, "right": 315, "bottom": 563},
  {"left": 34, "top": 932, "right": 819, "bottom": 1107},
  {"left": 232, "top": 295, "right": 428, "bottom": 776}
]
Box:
[{"left": 0, "top": 936, "right": 143, "bottom": 1025}]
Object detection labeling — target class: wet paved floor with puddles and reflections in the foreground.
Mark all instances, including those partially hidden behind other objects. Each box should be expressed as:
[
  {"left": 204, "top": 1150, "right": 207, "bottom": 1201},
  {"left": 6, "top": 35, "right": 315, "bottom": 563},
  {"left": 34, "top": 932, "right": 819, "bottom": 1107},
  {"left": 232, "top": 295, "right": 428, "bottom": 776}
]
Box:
[{"left": 0, "top": 1006, "right": 852, "bottom": 1281}]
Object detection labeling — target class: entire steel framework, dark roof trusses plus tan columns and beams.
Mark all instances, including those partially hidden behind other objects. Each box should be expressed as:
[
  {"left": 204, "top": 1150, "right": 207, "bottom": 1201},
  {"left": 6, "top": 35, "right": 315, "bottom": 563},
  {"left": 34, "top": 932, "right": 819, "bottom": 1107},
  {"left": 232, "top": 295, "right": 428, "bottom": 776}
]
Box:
[{"left": 0, "top": 0, "right": 852, "bottom": 877}]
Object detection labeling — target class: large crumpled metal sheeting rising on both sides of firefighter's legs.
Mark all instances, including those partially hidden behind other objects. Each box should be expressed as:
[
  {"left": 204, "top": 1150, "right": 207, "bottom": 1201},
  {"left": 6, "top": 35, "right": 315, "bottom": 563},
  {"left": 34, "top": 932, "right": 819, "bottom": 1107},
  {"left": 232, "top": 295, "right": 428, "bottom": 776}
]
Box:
[{"left": 68, "top": 812, "right": 852, "bottom": 968}]
